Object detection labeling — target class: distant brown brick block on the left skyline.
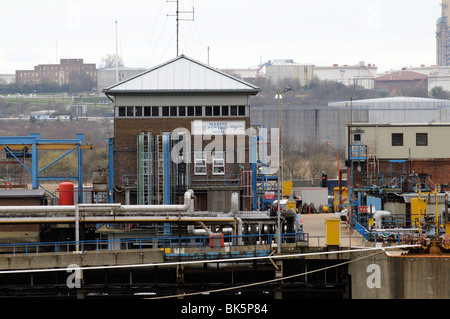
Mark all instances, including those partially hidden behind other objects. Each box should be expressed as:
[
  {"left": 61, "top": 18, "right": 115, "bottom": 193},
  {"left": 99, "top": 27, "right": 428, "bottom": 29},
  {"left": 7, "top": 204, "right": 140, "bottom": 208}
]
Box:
[{"left": 16, "top": 59, "right": 97, "bottom": 85}]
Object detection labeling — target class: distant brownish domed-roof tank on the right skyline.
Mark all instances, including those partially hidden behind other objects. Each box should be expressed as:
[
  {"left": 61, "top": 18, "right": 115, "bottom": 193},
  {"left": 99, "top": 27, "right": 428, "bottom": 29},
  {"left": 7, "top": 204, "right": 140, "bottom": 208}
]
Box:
[{"left": 374, "top": 70, "right": 428, "bottom": 95}]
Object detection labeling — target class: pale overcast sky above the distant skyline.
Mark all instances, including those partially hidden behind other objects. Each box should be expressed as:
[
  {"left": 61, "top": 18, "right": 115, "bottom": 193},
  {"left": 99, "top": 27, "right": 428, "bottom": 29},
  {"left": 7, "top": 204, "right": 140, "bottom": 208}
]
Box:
[{"left": 0, "top": 0, "right": 441, "bottom": 73}]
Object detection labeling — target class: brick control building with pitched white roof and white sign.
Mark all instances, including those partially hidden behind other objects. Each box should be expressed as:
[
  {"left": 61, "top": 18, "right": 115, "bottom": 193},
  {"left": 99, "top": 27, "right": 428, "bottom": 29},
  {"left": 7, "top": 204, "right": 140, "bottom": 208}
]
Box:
[{"left": 103, "top": 55, "right": 260, "bottom": 211}]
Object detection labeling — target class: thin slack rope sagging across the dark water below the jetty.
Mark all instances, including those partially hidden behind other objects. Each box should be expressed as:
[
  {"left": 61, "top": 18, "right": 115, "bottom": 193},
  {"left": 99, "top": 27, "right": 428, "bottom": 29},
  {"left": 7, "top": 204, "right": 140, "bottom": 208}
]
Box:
[{"left": 146, "top": 251, "right": 384, "bottom": 299}]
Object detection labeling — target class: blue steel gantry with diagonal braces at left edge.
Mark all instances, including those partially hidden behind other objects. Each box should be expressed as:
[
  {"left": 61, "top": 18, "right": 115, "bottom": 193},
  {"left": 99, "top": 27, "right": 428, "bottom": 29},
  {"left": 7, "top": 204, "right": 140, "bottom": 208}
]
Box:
[{"left": 0, "top": 134, "right": 92, "bottom": 203}]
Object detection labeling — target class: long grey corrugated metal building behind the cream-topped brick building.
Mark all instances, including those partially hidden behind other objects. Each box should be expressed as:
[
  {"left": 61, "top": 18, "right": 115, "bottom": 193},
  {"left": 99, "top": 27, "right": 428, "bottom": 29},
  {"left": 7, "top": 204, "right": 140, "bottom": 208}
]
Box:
[{"left": 251, "top": 97, "right": 450, "bottom": 152}]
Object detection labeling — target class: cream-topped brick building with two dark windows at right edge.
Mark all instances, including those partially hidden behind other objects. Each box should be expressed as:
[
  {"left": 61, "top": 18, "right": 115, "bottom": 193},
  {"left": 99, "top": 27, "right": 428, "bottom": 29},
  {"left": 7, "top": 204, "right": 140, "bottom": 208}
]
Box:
[{"left": 346, "top": 123, "right": 450, "bottom": 186}]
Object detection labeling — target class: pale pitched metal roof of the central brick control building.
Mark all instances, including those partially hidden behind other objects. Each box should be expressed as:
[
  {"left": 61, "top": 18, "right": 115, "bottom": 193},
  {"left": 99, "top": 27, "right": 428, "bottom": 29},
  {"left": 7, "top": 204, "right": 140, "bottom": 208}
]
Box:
[{"left": 103, "top": 55, "right": 261, "bottom": 95}]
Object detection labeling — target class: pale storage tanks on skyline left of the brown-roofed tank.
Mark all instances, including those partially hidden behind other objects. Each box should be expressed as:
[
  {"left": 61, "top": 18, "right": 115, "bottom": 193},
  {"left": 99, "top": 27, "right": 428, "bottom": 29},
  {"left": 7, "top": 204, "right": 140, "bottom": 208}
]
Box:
[{"left": 314, "top": 61, "right": 378, "bottom": 90}]
